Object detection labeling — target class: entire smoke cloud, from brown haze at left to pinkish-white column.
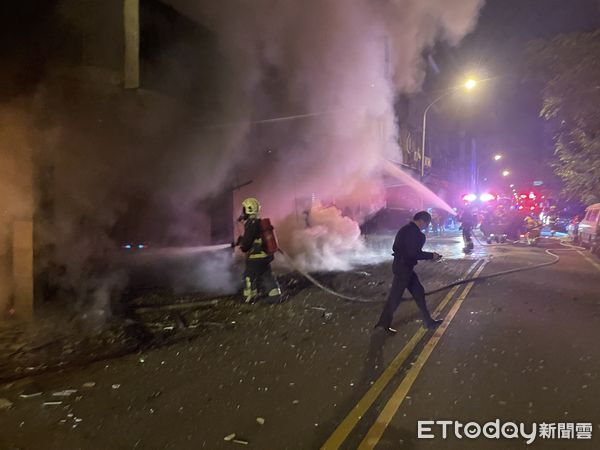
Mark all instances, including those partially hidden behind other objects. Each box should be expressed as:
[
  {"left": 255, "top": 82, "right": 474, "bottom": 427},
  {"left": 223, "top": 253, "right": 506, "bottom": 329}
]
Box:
[{"left": 0, "top": 0, "right": 483, "bottom": 316}]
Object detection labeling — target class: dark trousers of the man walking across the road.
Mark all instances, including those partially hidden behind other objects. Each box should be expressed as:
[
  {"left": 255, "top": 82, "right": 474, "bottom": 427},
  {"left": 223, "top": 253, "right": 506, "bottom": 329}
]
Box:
[{"left": 377, "top": 261, "right": 433, "bottom": 328}]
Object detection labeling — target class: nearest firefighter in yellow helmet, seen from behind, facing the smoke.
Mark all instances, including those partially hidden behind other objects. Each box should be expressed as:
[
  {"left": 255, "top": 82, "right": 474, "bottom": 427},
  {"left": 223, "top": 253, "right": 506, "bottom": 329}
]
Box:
[{"left": 233, "top": 198, "right": 281, "bottom": 303}]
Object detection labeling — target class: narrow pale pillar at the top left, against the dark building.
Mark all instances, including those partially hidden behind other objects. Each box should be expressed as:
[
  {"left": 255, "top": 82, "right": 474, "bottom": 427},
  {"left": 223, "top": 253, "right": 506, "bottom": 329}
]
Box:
[{"left": 123, "top": 0, "right": 140, "bottom": 89}]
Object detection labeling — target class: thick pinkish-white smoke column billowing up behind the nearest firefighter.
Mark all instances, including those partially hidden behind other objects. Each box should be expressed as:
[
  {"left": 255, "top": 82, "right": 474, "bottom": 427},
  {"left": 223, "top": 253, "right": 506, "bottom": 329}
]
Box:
[{"left": 165, "top": 0, "right": 482, "bottom": 270}]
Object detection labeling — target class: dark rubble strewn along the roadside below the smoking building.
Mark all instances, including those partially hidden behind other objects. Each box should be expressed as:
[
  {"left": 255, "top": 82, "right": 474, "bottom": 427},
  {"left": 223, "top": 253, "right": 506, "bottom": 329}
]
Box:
[{"left": 0, "top": 261, "right": 467, "bottom": 384}]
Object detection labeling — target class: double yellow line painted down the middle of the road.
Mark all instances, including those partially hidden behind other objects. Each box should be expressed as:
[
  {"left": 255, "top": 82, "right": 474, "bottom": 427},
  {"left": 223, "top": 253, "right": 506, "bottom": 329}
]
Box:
[{"left": 321, "top": 260, "right": 487, "bottom": 450}]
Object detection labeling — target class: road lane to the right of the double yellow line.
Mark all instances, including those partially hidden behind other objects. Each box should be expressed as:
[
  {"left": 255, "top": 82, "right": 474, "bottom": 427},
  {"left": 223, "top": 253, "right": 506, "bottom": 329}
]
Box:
[{"left": 376, "top": 248, "right": 600, "bottom": 450}]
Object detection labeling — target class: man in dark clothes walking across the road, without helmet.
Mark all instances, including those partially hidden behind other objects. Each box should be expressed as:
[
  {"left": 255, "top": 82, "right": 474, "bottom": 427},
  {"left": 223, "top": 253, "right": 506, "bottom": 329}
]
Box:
[{"left": 375, "top": 211, "right": 442, "bottom": 334}]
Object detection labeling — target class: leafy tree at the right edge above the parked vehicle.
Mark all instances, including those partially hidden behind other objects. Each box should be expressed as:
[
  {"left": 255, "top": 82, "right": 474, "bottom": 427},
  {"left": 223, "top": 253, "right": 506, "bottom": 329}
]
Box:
[{"left": 528, "top": 29, "right": 600, "bottom": 204}]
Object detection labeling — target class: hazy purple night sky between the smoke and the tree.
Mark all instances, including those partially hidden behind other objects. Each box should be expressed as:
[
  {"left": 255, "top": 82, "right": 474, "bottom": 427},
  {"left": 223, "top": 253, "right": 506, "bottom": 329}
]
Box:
[{"left": 436, "top": 0, "right": 600, "bottom": 194}]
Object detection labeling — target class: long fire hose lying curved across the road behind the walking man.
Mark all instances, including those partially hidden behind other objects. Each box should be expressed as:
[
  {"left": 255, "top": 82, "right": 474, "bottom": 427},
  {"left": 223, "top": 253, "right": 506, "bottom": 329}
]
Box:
[{"left": 278, "top": 241, "right": 582, "bottom": 303}]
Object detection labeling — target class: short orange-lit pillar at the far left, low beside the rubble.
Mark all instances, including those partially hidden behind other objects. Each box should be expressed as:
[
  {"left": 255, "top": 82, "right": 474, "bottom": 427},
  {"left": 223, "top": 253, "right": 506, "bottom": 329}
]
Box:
[{"left": 12, "top": 220, "right": 33, "bottom": 319}]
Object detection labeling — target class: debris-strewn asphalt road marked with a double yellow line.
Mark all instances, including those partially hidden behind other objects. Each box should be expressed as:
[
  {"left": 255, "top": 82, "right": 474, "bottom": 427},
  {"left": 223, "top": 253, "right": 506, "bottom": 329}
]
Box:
[{"left": 0, "top": 237, "right": 600, "bottom": 450}]
